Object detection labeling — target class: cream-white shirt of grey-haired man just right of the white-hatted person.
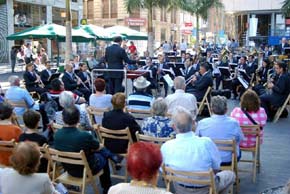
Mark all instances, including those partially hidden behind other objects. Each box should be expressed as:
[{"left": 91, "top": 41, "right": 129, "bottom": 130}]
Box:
[{"left": 165, "top": 89, "right": 197, "bottom": 120}]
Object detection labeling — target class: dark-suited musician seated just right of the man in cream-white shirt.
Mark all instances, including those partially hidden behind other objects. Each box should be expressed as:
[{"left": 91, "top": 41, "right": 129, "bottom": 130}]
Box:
[{"left": 186, "top": 62, "right": 213, "bottom": 102}]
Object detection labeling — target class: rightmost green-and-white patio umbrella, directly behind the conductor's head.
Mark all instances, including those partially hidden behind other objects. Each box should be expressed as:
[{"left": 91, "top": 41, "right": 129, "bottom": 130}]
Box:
[{"left": 105, "top": 26, "right": 148, "bottom": 40}]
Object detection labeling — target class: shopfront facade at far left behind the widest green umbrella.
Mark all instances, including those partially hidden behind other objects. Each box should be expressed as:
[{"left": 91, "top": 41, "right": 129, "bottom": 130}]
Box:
[{"left": 0, "top": 0, "right": 83, "bottom": 64}]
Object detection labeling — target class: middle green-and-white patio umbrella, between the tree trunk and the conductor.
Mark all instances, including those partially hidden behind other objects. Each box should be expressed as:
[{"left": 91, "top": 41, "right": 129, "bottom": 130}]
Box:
[{"left": 74, "top": 24, "right": 110, "bottom": 40}]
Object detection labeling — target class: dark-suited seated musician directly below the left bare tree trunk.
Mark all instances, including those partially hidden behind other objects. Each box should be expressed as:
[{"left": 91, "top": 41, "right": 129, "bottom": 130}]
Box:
[{"left": 62, "top": 64, "right": 91, "bottom": 102}]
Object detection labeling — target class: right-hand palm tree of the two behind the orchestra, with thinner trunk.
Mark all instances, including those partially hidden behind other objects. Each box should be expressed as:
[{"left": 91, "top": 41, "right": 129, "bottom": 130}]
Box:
[{"left": 181, "top": 0, "right": 223, "bottom": 48}]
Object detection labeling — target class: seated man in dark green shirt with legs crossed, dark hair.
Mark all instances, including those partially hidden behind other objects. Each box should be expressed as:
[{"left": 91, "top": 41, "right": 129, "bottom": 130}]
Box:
[{"left": 54, "top": 106, "right": 119, "bottom": 193}]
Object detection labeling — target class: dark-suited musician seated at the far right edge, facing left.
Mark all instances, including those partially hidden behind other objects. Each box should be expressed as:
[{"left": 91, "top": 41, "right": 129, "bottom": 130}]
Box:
[{"left": 260, "top": 62, "right": 290, "bottom": 118}]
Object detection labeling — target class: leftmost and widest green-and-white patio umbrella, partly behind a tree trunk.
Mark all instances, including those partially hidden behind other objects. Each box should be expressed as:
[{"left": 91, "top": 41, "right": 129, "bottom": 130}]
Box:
[{"left": 6, "top": 24, "right": 94, "bottom": 42}]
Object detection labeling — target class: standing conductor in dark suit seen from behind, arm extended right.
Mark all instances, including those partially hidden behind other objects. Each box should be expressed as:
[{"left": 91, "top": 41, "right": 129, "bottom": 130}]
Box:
[{"left": 105, "top": 36, "right": 136, "bottom": 94}]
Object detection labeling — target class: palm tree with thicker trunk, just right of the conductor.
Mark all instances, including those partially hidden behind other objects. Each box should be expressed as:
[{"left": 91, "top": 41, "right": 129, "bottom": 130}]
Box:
[{"left": 125, "top": 0, "right": 183, "bottom": 56}]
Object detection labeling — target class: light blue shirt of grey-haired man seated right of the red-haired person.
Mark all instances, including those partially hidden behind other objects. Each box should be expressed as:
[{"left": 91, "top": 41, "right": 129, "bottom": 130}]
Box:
[{"left": 161, "top": 131, "right": 221, "bottom": 172}]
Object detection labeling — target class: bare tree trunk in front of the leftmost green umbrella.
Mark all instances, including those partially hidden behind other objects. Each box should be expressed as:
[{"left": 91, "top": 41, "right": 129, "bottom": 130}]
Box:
[{"left": 65, "top": 0, "right": 72, "bottom": 63}]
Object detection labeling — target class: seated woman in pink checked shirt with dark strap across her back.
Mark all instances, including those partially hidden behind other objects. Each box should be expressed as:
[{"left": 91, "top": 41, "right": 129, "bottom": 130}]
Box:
[{"left": 231, "top": 90, "right": 267, "bottom": 148}]
